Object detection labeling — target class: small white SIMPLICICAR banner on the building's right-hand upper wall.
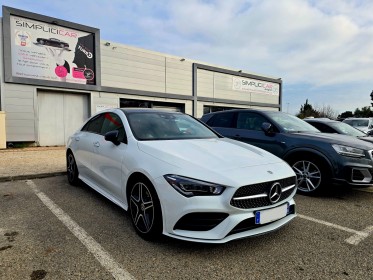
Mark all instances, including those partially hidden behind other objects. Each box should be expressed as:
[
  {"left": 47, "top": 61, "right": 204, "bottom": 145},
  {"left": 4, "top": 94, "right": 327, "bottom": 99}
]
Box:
[{"left": 232, "top": 77, "right": 280, "bottom": 96}]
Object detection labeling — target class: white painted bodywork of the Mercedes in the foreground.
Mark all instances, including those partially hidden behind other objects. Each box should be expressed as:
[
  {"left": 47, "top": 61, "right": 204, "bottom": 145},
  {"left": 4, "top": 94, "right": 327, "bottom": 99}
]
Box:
[{"left": 67, "top": 109, "right": 296, "bottom": 243}]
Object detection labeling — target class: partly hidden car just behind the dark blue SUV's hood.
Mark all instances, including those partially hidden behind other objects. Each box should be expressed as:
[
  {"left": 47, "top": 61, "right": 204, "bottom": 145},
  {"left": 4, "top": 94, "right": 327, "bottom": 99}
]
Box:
[{"left": 304, "top": 118, "right": 373, "bottom": 143}]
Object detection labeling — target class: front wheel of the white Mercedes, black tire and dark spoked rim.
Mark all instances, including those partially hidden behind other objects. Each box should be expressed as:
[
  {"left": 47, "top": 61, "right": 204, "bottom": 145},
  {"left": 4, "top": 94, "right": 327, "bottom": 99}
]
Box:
[{"left": 128, "top": 178, "right": 162, "bottom": 241}]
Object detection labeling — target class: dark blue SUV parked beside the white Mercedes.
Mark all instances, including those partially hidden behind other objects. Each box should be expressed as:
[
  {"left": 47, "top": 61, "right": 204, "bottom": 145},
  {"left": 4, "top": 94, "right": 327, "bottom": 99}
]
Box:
[{"left": 201, "top": 109, "right": 373, "bottom": 194}]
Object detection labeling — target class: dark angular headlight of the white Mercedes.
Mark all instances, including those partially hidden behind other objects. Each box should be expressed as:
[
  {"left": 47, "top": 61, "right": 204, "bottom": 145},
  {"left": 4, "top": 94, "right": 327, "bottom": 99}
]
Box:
[{"left": 163, "top": 174, "right": 225, "bottom": 197}]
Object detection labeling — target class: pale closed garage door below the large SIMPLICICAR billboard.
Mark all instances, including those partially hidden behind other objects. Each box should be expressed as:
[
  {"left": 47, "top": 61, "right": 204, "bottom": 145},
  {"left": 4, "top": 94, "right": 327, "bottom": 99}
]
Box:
[{"left": 38, "top": 92, "right": 89, "bottom": 146}]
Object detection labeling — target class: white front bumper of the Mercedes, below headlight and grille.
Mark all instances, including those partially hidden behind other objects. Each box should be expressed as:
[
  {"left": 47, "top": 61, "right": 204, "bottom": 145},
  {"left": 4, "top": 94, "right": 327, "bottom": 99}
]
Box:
[{"left": 156, "top": 178, "right": 296, "bottom": 243}]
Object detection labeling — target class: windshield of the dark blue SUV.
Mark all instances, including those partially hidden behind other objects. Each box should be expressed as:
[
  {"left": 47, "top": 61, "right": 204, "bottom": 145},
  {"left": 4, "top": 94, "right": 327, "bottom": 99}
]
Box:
[{"left": 267, "top": 112, "right": 320, "bottom": 132}]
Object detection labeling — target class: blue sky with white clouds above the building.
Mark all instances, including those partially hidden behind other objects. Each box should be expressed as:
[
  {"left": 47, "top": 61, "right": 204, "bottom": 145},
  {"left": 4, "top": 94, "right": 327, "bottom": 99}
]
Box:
[{"left": 0, "top": 0, "right": 373, "bottom": 114}]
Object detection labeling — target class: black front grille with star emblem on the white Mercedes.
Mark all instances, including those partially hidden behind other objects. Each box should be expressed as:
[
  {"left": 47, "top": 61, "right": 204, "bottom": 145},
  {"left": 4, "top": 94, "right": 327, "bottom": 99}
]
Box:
[{"left": 230, "top": 176, "right": 296, "bottom": 209}]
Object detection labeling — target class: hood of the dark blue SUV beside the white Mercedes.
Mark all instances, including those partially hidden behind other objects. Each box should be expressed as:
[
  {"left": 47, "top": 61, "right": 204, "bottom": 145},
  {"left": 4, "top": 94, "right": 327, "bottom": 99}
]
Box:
[{"left": 289, "top": 132, "right": 373, "bottom": 150}]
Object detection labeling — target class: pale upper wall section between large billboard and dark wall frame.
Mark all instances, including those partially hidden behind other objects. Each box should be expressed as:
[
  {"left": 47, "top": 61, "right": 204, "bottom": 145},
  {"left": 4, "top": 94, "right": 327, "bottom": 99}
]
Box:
[{"left": 101, "top": 41, "right": 192, "bottom": 95}]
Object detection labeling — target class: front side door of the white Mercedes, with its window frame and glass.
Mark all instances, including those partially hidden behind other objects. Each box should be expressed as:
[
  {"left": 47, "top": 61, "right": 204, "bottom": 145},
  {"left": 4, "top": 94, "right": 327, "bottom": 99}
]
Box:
[{"left": 92, "top": 112, "right": 127, "bottom": 200}]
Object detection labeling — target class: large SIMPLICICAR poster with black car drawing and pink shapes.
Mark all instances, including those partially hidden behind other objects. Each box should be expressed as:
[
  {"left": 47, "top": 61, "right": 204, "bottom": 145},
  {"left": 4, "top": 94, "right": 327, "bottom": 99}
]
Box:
[{"left": 10, "top": 15, "right": 96, "bottom": 85}]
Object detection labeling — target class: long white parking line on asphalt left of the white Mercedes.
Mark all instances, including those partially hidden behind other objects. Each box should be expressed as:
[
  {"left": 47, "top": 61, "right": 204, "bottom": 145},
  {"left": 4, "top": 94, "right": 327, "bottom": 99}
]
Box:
[{"left": 26, "top": 180, "right": 135, "bottom": 280}]
